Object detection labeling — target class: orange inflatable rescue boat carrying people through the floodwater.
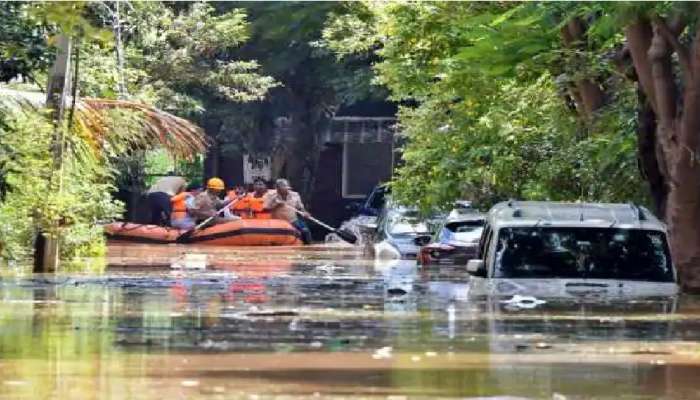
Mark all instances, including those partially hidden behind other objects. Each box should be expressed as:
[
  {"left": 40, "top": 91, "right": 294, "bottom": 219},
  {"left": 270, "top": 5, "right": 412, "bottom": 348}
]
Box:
[{"left": 105, "top": 219, "right": 302, "bottom": 246}]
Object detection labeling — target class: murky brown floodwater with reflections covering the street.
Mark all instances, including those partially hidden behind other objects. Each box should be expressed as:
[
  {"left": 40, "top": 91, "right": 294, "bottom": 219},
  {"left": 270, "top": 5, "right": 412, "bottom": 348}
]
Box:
[{"left": 0, "top": 245, "right": 700, "bottom": 399}]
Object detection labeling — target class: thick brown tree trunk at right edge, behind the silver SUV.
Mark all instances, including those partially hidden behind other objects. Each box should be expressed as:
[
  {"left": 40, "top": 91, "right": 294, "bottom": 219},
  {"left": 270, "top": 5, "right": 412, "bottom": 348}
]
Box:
[{"left": 625, "top": 17, "right": 700, "bottom": 293}]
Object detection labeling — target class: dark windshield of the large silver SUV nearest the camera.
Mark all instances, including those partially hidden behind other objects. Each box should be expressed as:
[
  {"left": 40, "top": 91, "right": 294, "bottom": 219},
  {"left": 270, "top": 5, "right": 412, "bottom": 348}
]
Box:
[{"left": 495, "top": 227, "right": 674, "bottom": 282}]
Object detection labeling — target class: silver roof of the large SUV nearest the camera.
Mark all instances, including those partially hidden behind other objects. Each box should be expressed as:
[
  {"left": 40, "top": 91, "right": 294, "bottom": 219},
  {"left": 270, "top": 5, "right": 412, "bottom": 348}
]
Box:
[{"left": 488, "top": 200, "right": 665, "bottom": 230}]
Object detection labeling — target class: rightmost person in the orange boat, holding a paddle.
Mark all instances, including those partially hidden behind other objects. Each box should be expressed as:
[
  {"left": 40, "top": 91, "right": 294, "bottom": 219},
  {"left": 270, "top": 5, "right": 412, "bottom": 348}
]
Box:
[{"left": 263, "top": 179, "right": 311, "bottom": 244}]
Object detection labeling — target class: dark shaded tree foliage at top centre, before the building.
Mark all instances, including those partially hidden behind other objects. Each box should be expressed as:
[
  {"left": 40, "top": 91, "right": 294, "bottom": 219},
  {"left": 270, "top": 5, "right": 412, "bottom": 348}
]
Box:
[{"left": 180, "top": 2, "right": 386, "bottom": 162}]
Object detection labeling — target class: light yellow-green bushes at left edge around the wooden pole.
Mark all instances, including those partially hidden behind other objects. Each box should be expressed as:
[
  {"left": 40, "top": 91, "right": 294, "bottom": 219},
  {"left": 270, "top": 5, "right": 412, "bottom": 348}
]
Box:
[{"left": 0, "top": 109, "right": 121, "bottom": 260}]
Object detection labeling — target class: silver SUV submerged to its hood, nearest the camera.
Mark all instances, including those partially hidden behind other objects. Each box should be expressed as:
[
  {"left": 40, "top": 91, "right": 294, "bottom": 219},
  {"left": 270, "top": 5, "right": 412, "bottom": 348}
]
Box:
[{"left": 467, "top": 201, "right": 678, "bottom": 297}]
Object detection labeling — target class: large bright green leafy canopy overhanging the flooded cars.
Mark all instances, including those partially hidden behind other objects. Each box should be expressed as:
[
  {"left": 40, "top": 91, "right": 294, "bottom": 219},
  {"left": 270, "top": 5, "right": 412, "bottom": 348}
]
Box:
[{"left": 320, "top": 2, "right": 647, "bottom": 211}]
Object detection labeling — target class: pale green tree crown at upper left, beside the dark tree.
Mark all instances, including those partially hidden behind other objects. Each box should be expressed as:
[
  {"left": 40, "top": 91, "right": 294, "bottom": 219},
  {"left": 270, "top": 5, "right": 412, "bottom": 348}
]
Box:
[{"left": 137, "top": 3, "right": 278, "bottom": 102}]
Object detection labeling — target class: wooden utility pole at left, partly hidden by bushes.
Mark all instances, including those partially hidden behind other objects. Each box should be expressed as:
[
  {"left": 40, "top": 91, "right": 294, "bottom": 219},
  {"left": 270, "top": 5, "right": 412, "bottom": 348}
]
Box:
[{"left": 34, "top": 35, "right": 72, "bottom": 272}]
